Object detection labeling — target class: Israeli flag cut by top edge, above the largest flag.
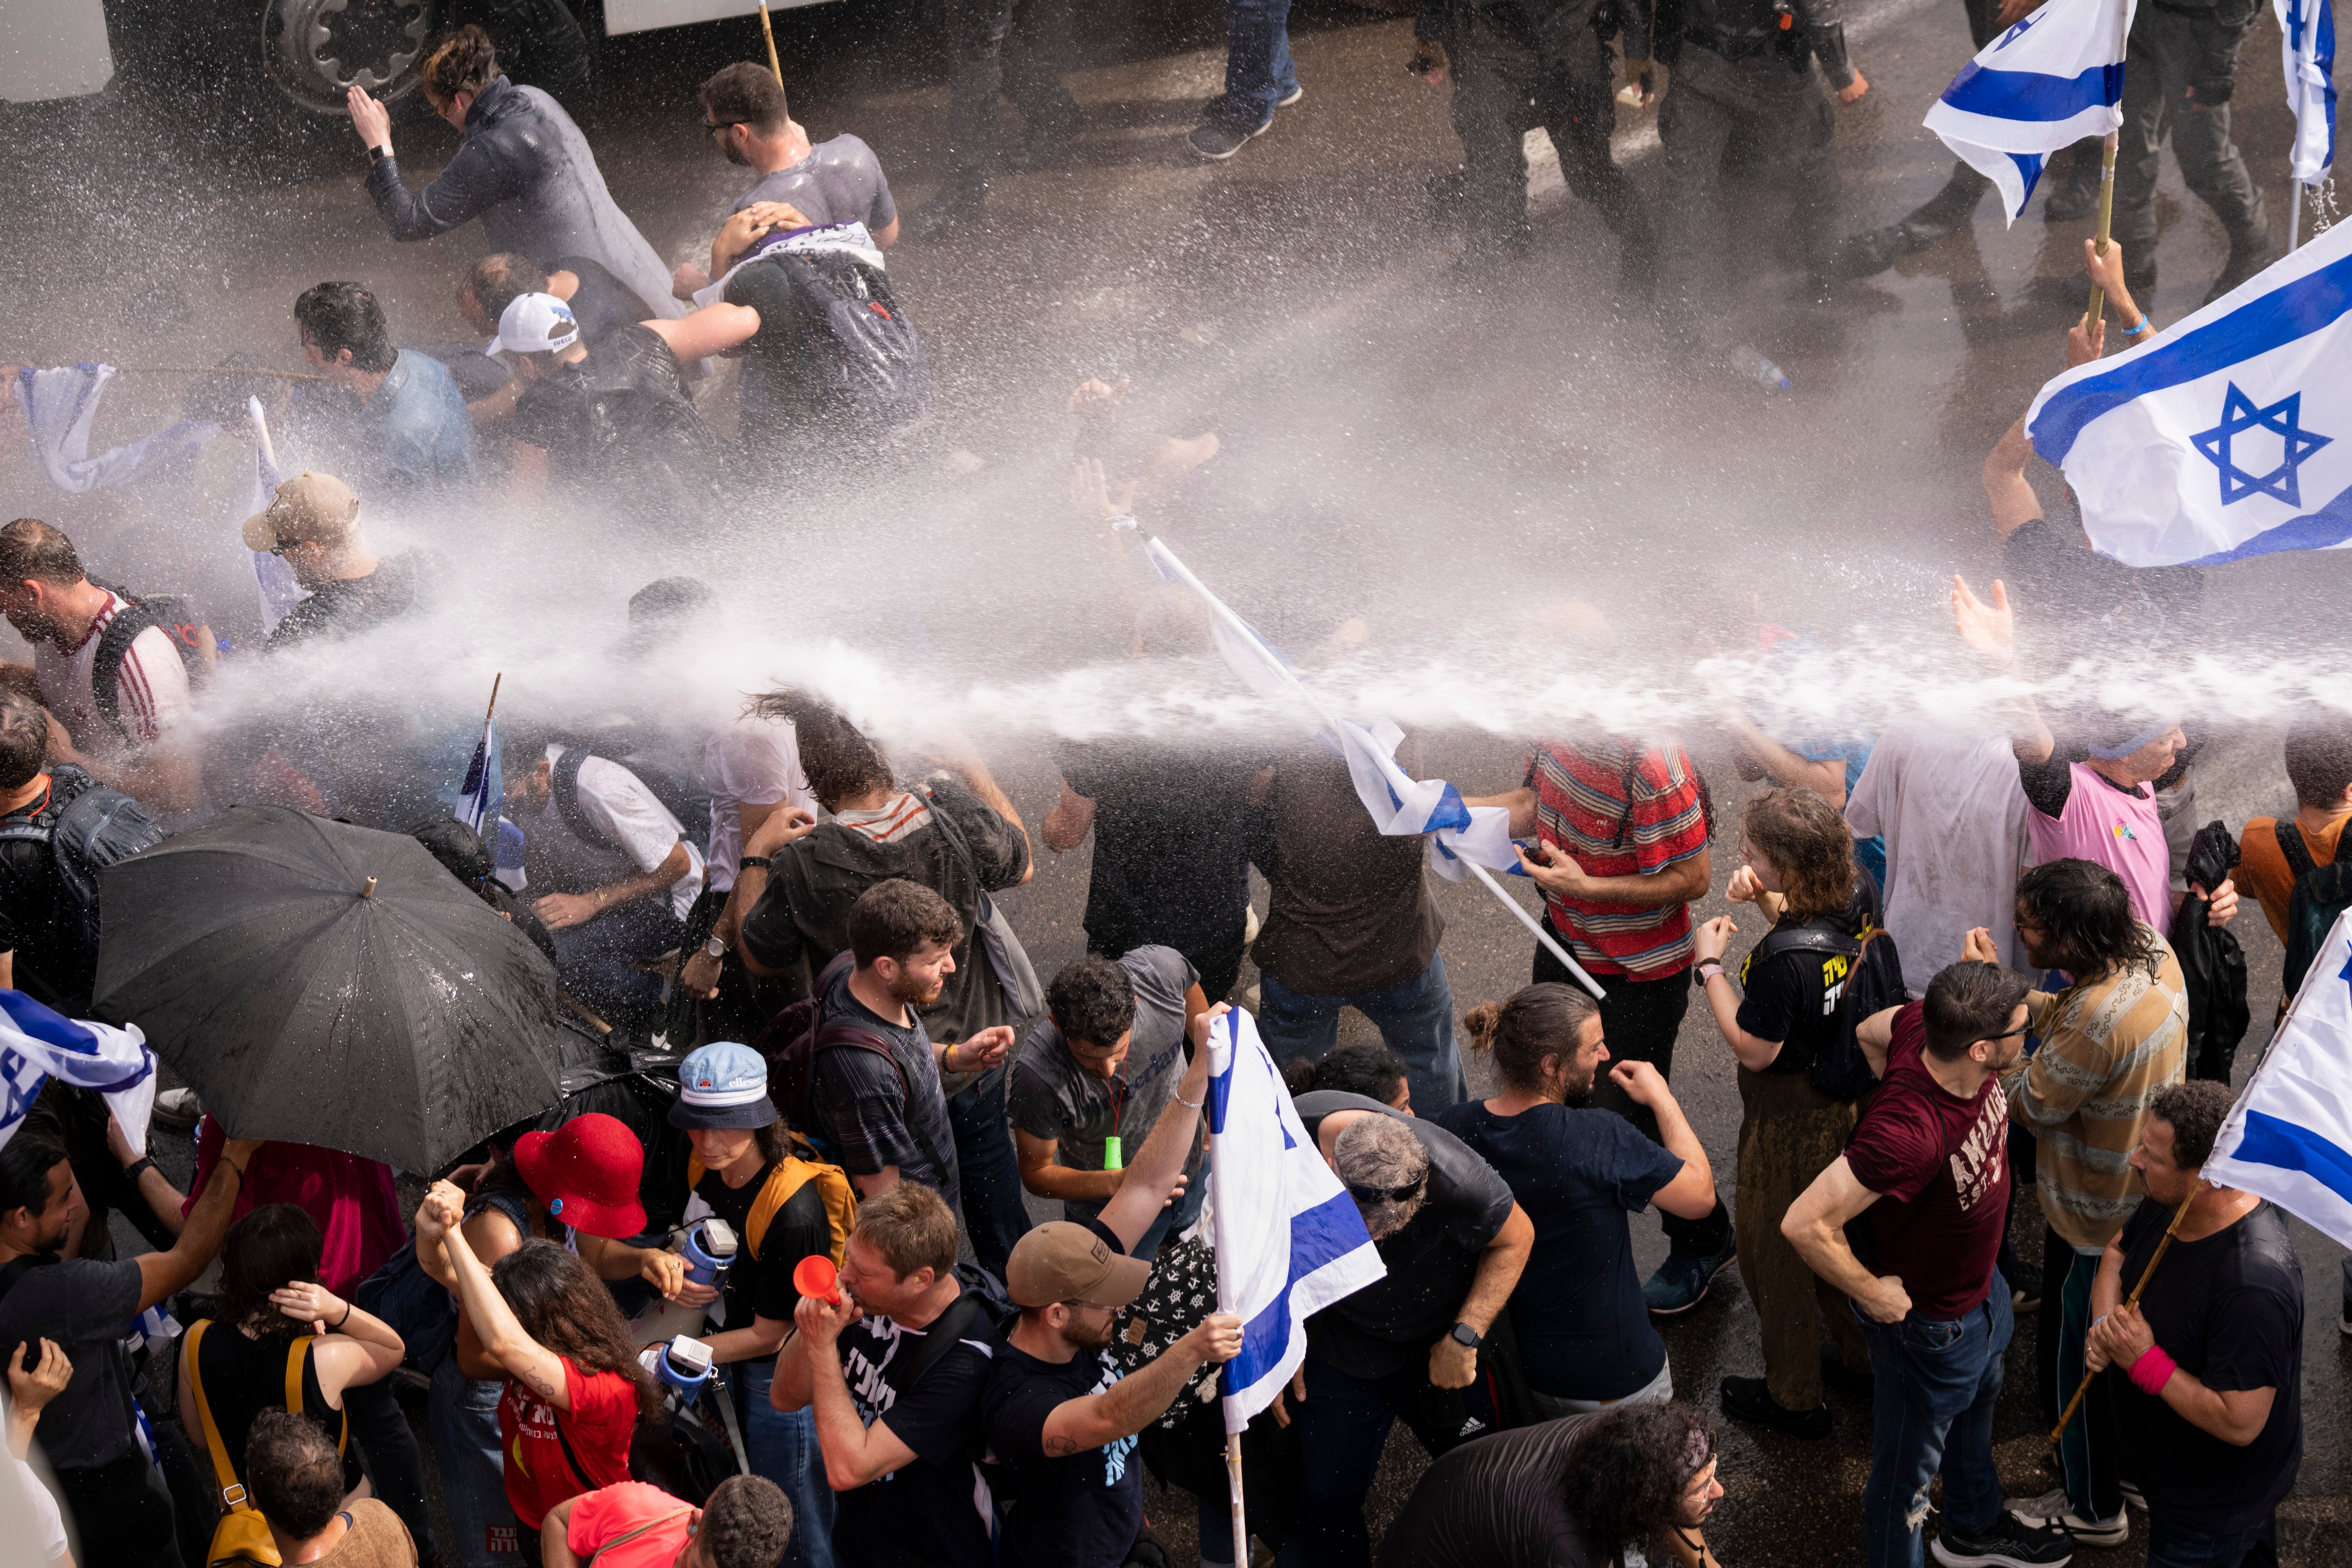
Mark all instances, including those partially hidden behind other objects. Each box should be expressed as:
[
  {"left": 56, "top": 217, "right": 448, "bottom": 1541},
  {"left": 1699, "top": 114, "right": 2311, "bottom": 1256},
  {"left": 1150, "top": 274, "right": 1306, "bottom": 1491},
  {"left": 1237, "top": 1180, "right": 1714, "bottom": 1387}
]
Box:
[{"left": 1926, "top": 0, "right": 2135, "bottom": 223}]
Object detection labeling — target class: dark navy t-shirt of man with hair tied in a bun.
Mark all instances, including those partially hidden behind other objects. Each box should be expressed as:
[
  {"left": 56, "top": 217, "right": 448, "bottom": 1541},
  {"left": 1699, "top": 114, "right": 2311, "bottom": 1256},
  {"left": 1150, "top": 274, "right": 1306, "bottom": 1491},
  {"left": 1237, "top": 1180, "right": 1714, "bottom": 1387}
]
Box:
[{"left": 1430, "top": 1100, "right": 1682, "bottom": 1399}]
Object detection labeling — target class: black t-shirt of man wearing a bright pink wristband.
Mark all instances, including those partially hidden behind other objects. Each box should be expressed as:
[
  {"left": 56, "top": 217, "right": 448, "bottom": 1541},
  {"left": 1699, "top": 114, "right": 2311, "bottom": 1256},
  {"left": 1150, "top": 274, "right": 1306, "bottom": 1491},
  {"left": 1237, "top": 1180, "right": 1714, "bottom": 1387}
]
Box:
[{"left": 2107, "top": 1199, "right": 2303, "bottom": 1533}]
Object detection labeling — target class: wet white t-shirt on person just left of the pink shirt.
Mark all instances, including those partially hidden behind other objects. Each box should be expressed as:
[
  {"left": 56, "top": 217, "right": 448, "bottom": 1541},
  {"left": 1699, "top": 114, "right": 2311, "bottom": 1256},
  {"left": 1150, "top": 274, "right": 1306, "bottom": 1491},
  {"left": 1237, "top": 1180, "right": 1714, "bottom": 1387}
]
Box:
[{"left": 1846, "top": 720, "right": 2032, "bottom": 997}]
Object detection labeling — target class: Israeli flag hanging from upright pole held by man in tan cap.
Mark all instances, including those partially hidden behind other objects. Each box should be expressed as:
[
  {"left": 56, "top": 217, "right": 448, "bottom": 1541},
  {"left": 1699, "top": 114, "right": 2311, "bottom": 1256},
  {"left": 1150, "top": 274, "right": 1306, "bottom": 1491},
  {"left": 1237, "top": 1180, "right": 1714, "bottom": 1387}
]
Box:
[{"left": 1209, "top": 1008, "right": 1388, "bottom": 1434}]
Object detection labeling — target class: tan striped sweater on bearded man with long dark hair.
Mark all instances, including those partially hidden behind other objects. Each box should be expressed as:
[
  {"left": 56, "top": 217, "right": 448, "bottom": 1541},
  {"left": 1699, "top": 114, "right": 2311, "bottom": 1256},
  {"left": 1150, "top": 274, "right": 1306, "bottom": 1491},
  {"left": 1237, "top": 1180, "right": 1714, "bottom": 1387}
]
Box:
[{"left": 2002, "top": 924, "right": 2190, "bottom": 1248}]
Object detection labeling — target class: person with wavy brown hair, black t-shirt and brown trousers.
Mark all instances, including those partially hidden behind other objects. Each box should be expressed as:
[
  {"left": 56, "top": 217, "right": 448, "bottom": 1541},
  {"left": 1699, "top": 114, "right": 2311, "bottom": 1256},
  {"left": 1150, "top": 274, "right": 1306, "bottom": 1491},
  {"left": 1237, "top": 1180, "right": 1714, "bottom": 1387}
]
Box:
[{"left": 1693, "top": 790, "right": 1884, "bottom": 1439}]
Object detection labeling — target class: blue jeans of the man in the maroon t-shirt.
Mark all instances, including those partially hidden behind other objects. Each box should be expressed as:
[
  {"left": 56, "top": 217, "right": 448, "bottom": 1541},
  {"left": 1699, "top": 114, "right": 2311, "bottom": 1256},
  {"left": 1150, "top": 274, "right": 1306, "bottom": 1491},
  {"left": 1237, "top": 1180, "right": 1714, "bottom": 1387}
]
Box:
[{"left": 1853, "top": 1269, "right": 2016, "bottom": 1568}]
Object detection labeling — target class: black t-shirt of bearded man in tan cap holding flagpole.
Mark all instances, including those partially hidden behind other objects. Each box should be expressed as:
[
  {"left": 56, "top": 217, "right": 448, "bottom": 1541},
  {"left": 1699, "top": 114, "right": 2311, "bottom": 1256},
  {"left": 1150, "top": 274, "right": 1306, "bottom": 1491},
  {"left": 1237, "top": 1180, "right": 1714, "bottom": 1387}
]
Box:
[{"left": 981, "top": 1340, "right": 1143, "bottom": 1568}]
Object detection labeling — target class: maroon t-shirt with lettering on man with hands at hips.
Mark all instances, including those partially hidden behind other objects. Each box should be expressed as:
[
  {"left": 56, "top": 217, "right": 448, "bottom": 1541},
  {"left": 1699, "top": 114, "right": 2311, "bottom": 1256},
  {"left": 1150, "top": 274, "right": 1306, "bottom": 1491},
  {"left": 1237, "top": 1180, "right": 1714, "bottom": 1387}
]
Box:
[{"left": 1846, "top": 1001, "right": 2009, "bottom": 1324}]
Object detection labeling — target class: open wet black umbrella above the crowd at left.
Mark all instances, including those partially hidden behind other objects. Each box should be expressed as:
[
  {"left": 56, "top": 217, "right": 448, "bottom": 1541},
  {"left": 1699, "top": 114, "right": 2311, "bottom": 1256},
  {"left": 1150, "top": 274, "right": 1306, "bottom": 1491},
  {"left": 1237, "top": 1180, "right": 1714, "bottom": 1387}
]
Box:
[{"left": 94, "top": 806, "right": 562, "bottom": 1171}]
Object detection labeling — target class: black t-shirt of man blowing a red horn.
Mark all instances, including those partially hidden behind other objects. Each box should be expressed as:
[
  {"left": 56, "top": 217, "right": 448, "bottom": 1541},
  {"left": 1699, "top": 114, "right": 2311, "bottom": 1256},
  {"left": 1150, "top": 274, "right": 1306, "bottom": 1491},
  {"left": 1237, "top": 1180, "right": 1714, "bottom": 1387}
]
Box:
[{"left": 833, "top": 1269, "right": 1002, "bottom": 1568}]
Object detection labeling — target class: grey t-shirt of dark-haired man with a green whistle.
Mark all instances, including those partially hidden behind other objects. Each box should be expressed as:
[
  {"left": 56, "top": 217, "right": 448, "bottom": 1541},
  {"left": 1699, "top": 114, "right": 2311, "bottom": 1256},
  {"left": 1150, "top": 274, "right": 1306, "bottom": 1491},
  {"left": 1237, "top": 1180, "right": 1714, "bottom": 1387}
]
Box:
[{"left": 1011, "top": 948, "right": 1199, "bottom": 1220}]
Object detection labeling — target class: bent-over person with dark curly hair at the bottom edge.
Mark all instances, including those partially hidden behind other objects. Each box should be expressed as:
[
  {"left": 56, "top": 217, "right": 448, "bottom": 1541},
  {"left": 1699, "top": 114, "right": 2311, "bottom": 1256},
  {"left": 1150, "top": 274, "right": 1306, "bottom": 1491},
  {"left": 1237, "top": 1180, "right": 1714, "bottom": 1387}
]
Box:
[{"left": 1381, "top": 1404, "right": 1724, "bottom": 1568}]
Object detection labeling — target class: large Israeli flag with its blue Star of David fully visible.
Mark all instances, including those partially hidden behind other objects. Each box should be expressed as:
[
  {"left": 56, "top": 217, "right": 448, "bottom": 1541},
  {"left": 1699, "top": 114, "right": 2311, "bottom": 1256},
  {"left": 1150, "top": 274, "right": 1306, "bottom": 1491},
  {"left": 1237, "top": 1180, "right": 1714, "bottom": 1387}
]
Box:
[{"left": 2025, "top": 223, "right": 2352, "bottom": 567}]
